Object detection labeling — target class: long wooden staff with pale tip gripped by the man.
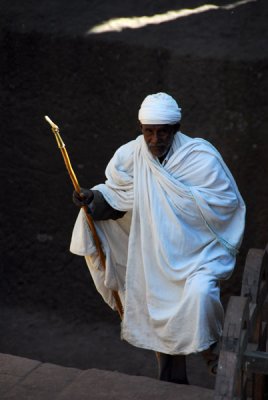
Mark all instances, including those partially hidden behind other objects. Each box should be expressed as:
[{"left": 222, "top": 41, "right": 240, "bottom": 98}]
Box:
[{"left": 45, "top": 116, "right": 123, "bottom": 319}]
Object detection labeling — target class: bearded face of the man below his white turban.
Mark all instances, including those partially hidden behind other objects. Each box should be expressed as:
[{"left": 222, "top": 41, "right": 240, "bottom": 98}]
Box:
[{"left": 141, "top": 124, "right": 179, "bottom": 158}]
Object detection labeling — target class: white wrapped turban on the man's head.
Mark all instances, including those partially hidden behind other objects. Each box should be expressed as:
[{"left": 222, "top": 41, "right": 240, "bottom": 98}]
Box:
[{"left": 139, "top": 93, "right": 181, "bottom": 125}]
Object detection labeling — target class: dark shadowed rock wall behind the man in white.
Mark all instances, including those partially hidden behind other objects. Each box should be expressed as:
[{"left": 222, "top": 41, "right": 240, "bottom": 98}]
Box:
[{"left": 0, "top": 30, "right": 268, "bottom": 319}]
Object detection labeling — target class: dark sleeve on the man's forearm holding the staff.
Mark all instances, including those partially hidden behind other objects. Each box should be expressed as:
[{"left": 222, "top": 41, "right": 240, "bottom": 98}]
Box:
[{"left": 88, "top": 190, "right": 125, "bottom": 221}]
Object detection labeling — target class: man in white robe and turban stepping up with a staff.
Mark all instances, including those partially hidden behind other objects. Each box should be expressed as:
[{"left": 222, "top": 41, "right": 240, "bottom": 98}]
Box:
[{"left": 71, "top": 93, "right": 245, "bottom": 383}]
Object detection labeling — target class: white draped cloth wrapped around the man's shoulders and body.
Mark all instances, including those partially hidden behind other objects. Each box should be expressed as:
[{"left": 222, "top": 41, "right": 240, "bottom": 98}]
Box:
[{"left": 71, "top": 132, "right": 245, "bottom": 354}]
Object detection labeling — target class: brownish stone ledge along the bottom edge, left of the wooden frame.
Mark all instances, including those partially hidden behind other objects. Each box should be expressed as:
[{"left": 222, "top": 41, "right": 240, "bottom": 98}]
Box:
[{"left": 0, "top": 353, "right": 213, "bottom": 400}]
